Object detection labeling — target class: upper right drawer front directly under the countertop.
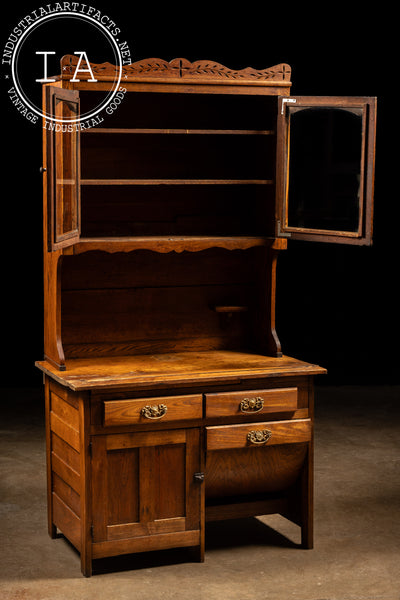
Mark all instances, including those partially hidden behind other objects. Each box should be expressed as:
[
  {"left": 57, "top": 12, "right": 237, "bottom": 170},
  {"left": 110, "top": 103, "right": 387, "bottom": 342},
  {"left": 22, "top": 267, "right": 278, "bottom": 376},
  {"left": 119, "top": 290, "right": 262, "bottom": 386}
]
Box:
[{"left": 206, "top": 387, "right": 298, "bottom": 419}]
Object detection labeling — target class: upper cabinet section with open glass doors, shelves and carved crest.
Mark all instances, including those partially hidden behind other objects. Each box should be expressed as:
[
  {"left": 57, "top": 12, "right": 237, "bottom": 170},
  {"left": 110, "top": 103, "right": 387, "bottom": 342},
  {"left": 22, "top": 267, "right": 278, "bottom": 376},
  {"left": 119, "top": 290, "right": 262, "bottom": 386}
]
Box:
[{"left": 45, "top": 56, "right": 376, "bottom": 253}]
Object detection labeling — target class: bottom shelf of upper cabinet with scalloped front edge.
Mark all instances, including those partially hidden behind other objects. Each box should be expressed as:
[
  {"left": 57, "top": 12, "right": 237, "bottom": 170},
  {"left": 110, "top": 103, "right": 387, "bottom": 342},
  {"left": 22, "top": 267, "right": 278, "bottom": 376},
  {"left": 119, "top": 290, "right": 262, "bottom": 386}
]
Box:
[{"left": 69, "top": 236, "right": 287, "bottom": 254}]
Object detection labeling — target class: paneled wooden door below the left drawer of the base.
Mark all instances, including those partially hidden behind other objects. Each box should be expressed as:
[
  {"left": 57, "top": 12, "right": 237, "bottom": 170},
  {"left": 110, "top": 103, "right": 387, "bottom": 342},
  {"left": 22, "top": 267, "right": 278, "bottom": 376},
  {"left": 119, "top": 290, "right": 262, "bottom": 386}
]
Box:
[{"left": 92, "top": 429, "right": 200, "bottom": 542}]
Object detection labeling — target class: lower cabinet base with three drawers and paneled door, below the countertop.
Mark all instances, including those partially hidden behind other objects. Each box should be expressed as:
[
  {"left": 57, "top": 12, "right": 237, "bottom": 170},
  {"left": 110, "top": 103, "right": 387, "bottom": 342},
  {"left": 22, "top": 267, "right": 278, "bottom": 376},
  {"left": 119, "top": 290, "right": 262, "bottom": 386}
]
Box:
[{"left": 45, "top": 377, "right": 313, "bottom": 576}]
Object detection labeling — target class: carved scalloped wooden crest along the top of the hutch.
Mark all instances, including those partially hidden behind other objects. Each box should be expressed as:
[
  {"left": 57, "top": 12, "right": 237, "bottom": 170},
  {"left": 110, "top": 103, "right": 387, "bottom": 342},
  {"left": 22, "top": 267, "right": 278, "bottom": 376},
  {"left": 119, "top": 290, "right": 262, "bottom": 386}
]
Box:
[{"left": 61, "top": 55, "right": 291, "bottom": 86}]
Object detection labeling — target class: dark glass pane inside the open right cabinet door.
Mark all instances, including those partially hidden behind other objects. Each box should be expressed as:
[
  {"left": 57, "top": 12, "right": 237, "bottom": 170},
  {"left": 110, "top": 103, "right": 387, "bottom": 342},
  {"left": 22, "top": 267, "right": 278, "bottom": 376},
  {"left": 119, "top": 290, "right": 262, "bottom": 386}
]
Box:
[{"left": 287, "top": 107, "right": 363, "bottom": 233}]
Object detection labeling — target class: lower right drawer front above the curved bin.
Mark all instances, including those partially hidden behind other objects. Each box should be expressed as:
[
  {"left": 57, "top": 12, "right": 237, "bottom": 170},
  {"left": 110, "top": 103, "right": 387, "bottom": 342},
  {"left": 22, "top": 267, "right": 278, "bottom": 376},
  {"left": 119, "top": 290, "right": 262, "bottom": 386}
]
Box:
[{"left": 206, "top": 419, "right": 312, "bottom": 450}]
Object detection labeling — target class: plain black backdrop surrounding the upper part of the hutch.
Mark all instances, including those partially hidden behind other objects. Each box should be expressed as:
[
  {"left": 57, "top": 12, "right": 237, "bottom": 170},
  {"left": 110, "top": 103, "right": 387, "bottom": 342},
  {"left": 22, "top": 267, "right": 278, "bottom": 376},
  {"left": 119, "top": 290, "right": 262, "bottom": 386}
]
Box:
[{"left": 0, "top": 1, "right": 399, "bottom": 386}]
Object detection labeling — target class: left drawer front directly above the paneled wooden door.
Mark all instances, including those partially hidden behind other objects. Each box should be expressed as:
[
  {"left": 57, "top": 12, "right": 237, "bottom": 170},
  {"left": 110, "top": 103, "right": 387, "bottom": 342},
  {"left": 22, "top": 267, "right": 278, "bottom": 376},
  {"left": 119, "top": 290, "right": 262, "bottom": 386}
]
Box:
[{"left": 103, "top": 394, "right": 203, "bottom": 427}]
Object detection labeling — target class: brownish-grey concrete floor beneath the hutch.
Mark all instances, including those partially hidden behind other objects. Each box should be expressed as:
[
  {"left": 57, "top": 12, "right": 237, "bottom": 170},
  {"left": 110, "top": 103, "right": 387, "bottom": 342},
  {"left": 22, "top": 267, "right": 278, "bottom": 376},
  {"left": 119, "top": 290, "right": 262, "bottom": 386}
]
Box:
[{"left": 0, "top": 386, "right": 400, "bottom": 600}]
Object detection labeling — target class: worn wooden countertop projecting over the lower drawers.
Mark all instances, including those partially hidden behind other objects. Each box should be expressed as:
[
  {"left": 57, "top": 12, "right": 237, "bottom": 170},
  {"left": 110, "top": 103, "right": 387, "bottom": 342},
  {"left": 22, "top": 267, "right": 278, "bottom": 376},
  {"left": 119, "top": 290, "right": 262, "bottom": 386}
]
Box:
[{"left": 35, "top": 350, "right": 326, "bottom": 390}]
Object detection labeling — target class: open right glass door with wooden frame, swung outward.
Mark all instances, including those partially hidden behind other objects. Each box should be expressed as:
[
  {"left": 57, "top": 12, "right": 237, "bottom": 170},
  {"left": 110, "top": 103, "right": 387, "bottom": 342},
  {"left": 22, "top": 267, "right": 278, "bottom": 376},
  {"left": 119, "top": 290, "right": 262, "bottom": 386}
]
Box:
[{"left": 277, "top": 96, "right": 376, "bottom": 244}]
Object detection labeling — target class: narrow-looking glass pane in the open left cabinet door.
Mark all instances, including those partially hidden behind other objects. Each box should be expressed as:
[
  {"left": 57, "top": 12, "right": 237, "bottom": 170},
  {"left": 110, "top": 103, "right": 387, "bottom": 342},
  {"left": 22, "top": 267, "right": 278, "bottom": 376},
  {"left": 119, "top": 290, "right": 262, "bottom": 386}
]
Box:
[{"left": 54, "top": 98, "right": 78, "bottom": 241}]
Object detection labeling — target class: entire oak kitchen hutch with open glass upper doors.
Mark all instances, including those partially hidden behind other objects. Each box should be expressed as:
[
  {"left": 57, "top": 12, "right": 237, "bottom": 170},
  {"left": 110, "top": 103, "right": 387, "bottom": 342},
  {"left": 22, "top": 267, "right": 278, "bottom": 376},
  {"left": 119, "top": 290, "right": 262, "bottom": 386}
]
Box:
[{"left": 36, "top": 56, "right": 376, "bottom": 576}]
